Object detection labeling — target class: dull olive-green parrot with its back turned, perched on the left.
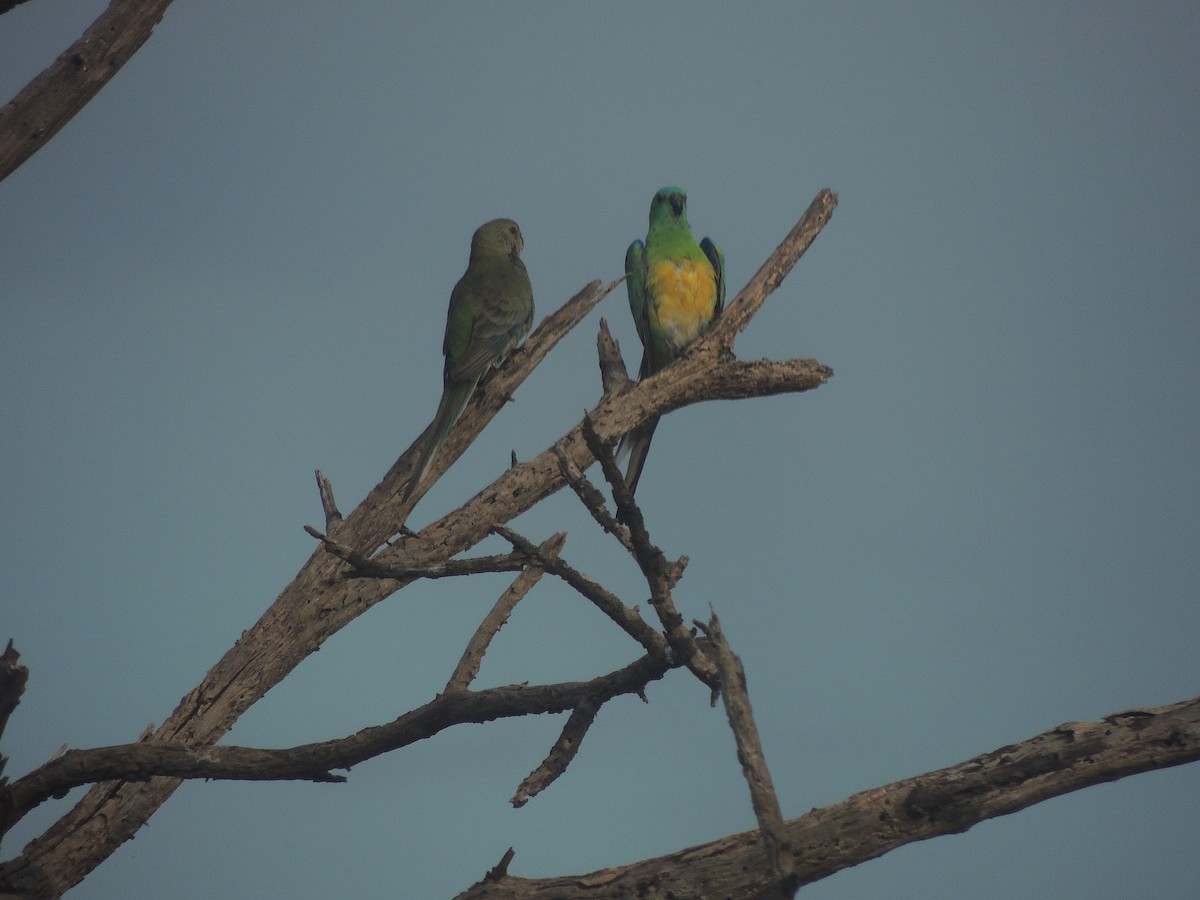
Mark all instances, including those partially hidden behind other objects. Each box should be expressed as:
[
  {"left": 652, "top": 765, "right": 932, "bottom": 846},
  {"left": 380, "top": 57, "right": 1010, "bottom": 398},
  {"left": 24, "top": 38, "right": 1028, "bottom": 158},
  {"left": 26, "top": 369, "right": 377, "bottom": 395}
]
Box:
[{"left": 404, "top": 218, "right": 533, "bottom": 499}]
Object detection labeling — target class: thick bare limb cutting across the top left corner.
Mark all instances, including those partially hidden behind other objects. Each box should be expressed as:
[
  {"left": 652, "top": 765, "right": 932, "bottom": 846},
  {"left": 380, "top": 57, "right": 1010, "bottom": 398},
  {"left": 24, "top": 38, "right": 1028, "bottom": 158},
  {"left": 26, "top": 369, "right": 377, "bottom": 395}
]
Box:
[{"left": 0, "top": 0, "right": 170, "bottom": 181}]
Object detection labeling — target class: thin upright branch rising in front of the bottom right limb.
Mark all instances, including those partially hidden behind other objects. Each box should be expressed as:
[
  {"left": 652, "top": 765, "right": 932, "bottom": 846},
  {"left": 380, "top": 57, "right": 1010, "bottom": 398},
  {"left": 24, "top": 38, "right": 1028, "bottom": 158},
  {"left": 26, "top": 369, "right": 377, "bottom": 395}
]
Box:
[{"left": 696, "top": 606, "right": 799, "bottom": 898}]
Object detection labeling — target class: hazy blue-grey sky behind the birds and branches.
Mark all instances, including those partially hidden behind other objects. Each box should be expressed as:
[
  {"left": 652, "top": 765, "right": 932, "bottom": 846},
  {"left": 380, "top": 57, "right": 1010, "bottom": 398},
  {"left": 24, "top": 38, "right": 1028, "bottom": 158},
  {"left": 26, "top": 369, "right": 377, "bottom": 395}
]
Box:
[{"left": 0, "top": 0, "right": 1200, "bottom": 900}]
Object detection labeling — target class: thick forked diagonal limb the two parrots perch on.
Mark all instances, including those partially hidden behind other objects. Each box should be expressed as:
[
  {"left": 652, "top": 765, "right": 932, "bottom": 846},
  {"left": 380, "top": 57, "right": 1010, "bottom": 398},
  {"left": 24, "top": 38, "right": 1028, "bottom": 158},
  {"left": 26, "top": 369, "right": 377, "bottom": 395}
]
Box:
[{"left": 0, "top": 199, "right": 833, "bottom": 896}]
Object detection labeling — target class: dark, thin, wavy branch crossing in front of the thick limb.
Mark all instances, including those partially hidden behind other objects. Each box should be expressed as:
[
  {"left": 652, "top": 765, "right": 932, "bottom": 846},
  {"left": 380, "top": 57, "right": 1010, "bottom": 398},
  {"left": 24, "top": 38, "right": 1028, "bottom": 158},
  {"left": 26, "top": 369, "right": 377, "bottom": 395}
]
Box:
[{"left": 0, "top": 656, "right": 671, "bottom": 840}]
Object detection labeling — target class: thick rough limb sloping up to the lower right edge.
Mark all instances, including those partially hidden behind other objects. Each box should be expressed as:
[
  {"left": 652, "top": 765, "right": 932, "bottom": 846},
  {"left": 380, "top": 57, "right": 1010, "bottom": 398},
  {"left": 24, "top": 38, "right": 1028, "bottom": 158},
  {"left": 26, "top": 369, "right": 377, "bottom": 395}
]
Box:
[{"left": 457, "top": 697, "right": 1200, "bottom": 900}]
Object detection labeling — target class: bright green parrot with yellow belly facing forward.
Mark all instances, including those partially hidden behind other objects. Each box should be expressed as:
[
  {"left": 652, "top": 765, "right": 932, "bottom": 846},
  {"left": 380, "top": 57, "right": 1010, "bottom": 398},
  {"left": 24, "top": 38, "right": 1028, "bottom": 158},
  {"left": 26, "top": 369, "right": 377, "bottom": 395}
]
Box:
[{"left": 618, "top": 187, "right": 725, "bottom": 491}]
